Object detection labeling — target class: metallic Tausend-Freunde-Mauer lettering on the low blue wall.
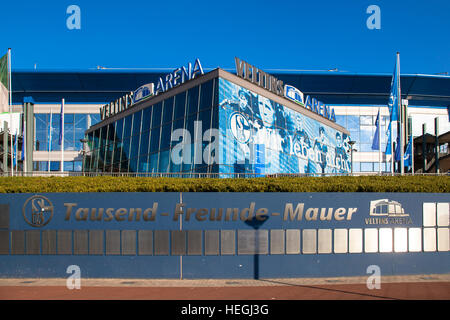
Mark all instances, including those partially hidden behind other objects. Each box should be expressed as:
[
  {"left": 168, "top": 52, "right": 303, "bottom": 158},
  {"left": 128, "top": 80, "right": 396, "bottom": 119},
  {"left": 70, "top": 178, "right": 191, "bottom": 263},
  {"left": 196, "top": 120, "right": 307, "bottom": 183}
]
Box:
[{"left": 64, "top": 202, "right": 358, "bottom": 222}]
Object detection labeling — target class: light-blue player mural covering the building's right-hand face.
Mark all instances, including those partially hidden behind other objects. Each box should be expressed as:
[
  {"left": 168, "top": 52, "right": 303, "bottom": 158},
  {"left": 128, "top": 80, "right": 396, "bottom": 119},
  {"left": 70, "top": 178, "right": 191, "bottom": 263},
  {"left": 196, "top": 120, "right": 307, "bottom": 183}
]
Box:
[{"left": 219, "top": 78, "right": 351, "bottom": 174}]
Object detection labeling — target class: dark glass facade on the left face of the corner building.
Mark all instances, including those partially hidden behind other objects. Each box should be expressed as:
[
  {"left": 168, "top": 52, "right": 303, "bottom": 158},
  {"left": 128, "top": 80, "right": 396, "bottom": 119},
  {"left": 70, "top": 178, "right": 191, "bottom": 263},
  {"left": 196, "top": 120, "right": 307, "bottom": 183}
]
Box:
[{"left": 85, "top": 79, "right": 218, "bottom": 173}]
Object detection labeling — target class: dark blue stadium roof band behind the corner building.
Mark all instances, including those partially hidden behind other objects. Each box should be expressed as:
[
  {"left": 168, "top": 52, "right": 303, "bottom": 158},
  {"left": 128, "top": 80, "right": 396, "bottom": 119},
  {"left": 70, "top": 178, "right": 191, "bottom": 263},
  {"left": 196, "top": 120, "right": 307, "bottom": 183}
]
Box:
[{"left": 12, "top": 69, "right": 450, "bottom": 107}]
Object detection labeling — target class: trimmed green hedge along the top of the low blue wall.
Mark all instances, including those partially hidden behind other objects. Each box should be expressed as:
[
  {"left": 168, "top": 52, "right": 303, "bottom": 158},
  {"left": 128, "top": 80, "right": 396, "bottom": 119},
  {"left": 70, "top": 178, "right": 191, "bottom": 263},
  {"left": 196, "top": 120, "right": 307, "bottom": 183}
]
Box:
[{"left": 0, "top": 176, "right": 450, "bottom": 193}]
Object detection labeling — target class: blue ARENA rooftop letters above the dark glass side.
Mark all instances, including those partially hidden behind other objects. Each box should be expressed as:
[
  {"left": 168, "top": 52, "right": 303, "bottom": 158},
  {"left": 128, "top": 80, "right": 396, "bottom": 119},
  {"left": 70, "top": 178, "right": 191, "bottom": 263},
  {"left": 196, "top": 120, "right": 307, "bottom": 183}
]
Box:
[{"left": 155, "top": 58, "right": 204, "bottom": 94}]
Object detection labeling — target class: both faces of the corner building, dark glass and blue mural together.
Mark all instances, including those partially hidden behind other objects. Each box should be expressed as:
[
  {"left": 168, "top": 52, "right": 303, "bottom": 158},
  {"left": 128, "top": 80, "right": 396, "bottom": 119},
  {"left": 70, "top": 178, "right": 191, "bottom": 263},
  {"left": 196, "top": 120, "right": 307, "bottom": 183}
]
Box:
[{"left": 84, "top": 78, "right": 351, "bottom": 177}]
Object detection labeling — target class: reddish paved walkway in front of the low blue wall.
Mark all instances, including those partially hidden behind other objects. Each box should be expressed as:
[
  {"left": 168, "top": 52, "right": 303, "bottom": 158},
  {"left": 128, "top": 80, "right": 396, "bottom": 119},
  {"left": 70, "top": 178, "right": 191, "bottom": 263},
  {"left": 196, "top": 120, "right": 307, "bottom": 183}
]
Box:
[{"left": 0, "top": 274, "right": 450, "bottom": 300}]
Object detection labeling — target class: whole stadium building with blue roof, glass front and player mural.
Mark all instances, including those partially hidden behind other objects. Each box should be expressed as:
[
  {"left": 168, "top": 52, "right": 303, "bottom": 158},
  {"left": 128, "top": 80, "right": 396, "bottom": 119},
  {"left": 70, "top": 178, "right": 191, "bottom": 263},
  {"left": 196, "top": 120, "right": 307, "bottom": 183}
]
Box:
[{"left": 4, "top": 58, "right": 450, "bottom": 176}]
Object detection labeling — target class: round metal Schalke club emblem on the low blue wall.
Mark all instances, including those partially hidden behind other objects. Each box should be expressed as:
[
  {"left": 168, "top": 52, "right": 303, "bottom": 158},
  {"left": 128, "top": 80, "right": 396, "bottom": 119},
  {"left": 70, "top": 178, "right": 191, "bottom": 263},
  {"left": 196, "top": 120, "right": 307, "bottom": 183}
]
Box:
[{"left": 22, "top": 195, "right": 53, "bottom": 228}]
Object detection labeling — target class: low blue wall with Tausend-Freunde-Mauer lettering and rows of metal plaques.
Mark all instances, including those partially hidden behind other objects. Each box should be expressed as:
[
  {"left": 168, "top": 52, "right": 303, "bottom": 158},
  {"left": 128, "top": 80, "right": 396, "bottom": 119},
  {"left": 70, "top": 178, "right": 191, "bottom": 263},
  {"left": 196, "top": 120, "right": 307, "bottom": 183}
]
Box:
[{"left": 0, "top": 193, "right": 450, "bottom": 278}]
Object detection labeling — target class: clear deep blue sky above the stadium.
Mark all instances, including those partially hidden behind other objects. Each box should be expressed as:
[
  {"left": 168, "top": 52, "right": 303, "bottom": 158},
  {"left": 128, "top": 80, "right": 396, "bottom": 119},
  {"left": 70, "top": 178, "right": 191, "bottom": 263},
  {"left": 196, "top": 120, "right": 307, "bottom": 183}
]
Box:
[{"left": 0, "top": 0, "right": 450, "bottom": 74}]
